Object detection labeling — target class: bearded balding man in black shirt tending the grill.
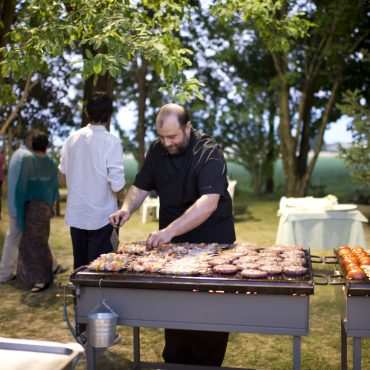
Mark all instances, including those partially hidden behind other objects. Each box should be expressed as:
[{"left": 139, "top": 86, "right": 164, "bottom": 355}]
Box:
[{"left": 110, "top": 104, "right": 235, "bottom": 366}]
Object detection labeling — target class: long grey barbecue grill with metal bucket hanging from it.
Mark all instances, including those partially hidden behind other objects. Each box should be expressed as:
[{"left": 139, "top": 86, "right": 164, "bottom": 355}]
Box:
[{"left": 70, "top": 251, "right": 327, "bottom": 370}]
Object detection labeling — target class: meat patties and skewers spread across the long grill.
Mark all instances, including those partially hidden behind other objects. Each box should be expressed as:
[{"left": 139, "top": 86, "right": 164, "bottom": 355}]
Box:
[{"left": 88, "top": 242, "right": 310, "bottom": 279}]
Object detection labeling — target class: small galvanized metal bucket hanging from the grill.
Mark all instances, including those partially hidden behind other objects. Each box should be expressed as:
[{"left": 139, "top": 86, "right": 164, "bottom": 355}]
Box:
[{"left": 88, "top": 312, "right": 118, "bottom": 348}]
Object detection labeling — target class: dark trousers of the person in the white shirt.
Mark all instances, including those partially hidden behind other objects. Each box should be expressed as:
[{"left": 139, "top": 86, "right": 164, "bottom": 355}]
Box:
[{"left": 70, "top": 224, "right": 113, "bottom": 269}]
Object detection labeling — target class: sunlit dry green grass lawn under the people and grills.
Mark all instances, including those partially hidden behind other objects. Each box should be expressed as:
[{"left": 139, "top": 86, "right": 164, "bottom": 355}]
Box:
[{"left": 0, "top": 189, "right": 370, "bottom": 370}]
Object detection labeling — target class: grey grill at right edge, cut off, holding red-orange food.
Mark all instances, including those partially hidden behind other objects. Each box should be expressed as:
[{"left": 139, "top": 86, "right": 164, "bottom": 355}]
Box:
[{"left": 325, "top": 249, "right": 370, "bottom": 370}]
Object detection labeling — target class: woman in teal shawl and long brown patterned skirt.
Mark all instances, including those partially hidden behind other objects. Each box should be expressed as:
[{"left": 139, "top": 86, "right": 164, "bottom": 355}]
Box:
[{"left": 15, "top": 131, "right": 59, "bottom": 293}]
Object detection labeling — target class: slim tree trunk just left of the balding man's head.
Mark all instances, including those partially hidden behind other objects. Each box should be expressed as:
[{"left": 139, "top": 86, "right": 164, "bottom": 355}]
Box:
[{"left": 135, "top": 57, "right": 148, "bottom": 168}]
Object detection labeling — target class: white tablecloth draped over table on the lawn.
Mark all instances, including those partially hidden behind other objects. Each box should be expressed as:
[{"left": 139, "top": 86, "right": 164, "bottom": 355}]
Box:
[{"left": 276, "top": 208, "right": 368, "bottom": 249}]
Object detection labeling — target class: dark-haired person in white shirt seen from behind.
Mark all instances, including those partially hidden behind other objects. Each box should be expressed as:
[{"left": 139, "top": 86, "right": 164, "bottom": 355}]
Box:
[{"left": 59, "top": 93, "right": 125, "bottom": 269}]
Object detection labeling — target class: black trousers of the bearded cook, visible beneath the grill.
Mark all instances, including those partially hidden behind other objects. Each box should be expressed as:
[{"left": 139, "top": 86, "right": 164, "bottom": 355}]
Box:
[{"left": 162, "top": 329, "right": 229, "bottom": 366}]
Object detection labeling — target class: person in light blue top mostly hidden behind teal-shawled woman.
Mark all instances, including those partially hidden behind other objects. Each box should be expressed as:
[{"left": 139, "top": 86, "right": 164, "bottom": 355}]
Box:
[{"left": 0, "top": 130, "right": 68, "bottom": 283}]
